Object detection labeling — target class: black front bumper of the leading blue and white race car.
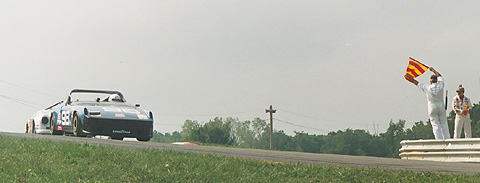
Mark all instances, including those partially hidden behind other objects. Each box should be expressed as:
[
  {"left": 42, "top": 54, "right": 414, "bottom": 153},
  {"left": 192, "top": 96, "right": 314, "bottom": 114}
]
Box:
[{"left": 83, "top": 116, "right": 153, "bottom": 138}]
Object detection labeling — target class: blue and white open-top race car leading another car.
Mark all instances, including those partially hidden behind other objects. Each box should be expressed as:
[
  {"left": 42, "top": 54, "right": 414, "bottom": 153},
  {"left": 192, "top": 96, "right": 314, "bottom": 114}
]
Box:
[{"left": 49, "top": 89, "right": 153, "bottom": 141}]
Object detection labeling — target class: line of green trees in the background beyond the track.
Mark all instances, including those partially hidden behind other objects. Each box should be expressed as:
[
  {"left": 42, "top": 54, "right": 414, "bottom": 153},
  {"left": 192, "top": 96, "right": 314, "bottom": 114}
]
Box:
[{"left": 151, "top": 103, "right": 480, "bottom": 158}]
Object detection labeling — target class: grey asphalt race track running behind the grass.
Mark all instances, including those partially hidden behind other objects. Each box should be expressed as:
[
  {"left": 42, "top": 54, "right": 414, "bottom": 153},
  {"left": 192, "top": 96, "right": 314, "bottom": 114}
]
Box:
[{"left": 0, "top": 132, "right": 480, "bottom": 175}]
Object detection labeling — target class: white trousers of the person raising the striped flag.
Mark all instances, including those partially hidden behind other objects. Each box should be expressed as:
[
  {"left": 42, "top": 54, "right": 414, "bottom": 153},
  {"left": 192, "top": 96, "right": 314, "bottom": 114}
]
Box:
[{"left": 428, "top": 103, "right": 450, "bottom": 139}]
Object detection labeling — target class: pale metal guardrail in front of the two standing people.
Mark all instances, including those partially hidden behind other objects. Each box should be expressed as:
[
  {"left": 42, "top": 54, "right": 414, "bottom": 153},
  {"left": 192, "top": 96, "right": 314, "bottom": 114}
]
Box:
[{"left": 399, "top": 138, "right": 480, "bottom": 163}]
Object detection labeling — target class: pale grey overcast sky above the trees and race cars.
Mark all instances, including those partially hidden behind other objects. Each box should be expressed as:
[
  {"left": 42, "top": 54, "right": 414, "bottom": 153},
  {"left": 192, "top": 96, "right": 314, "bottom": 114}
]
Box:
[{"left": 0, "top": 0, "right": 480, "bottom": 135}]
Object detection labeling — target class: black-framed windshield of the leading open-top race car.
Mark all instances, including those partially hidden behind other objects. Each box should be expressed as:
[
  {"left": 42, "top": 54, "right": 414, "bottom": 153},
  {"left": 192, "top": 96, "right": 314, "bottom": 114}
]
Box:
[{"left": 70, "top": 93, "right": 125, "bottom": 102}]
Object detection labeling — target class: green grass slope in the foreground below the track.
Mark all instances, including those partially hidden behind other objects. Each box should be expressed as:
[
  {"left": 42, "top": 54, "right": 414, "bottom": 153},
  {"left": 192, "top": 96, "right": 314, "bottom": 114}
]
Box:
[{"left": 0, "top": 136, "right": 480, "bottom": 182}]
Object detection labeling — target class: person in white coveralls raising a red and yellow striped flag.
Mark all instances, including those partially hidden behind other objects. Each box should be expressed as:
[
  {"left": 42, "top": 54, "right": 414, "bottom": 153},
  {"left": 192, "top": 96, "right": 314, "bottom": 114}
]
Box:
[{"left": 405, "top": 67, "right": 450, "bottom": 139}]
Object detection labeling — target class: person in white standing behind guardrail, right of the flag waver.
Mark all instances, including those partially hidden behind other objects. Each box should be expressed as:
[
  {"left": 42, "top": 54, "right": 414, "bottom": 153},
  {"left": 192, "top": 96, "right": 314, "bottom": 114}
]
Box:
[{"left": 452, "top": 85, "right": 472, "bottom": 139}]
